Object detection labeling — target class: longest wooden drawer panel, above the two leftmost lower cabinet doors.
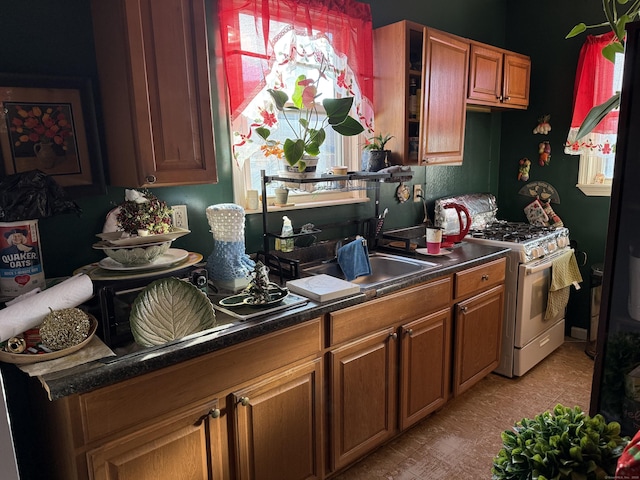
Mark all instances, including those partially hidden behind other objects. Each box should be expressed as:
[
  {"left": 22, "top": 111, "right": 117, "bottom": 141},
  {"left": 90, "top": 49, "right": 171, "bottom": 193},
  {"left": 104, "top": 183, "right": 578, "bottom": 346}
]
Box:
[{"left": 80, "top": 318, "right": 322, "bottom": 443}]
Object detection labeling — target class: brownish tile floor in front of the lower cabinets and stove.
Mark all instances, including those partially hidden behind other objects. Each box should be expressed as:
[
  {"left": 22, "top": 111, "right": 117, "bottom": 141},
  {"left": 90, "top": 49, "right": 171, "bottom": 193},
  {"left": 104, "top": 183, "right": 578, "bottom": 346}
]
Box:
[{"left": 333, "top": 338, "right": 593, "bottom": 480}]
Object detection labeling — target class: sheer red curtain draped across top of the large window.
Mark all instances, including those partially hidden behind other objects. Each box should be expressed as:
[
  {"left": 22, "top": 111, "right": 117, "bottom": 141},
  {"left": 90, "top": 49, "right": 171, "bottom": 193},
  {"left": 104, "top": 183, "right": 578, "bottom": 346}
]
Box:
[{"left": 218, "top": 0, "right": 373, "bottom": 119}]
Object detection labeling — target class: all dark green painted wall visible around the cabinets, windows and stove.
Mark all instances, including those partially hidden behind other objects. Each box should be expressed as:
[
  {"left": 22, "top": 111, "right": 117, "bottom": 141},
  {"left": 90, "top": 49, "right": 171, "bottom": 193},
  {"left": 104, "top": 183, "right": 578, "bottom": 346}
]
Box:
[{"left": 0, "top": 0, "right": 608, "bottom": 330}]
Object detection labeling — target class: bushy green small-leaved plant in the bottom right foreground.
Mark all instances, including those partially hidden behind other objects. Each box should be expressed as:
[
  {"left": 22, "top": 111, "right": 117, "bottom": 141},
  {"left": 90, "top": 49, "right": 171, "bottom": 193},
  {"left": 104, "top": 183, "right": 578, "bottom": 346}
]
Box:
[{"left": 491, "top": 404, "right": 629, "bottom": 480}]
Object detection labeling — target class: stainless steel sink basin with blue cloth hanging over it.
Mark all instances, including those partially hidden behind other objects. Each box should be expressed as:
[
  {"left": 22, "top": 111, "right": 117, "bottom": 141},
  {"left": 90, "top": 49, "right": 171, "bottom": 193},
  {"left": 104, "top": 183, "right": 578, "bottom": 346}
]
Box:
[{"left": 303, "top": 252, "right": 438, "bottom": 287}]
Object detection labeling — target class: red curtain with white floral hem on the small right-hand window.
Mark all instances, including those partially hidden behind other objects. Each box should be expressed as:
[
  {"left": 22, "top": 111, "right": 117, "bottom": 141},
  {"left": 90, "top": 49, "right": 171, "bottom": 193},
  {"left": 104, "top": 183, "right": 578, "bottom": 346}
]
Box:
[{"left": 565, "top": 32, "right": 618, "bottom": 155}]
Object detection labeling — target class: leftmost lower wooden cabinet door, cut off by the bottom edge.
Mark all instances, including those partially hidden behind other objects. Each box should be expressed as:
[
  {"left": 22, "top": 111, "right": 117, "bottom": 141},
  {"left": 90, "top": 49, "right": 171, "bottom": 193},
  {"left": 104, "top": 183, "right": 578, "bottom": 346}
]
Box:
[{"left": 87, "top": 400, "right": 227, "bottom": 480}]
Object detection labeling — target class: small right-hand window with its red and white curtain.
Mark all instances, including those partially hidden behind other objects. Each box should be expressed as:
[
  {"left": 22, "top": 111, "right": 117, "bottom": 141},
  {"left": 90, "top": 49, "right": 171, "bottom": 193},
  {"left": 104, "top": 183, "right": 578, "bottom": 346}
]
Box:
[{"left": 565, "top": 32, "right": 624, "bottom": 196}]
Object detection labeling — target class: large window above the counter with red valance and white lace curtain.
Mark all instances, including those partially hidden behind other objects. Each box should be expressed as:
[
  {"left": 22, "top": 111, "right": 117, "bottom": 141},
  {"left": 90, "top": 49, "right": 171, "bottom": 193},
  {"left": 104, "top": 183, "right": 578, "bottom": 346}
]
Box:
[{"left": 218, "top": 0, "right": 373, "bottom": 210}]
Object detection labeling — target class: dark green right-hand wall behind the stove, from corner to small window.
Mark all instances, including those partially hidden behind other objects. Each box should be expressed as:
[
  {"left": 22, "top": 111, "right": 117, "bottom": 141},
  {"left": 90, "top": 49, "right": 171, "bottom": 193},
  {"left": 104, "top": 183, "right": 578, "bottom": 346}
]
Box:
[{"left": 498, "top": 0, "right": 609, "bottom": 328}]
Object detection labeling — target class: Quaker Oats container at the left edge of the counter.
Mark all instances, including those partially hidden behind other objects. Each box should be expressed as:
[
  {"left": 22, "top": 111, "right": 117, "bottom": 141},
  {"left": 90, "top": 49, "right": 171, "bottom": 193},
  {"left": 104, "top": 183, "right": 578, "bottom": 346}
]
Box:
[{"left": 0, "top": 220, "right": 45, "bottom": 297}]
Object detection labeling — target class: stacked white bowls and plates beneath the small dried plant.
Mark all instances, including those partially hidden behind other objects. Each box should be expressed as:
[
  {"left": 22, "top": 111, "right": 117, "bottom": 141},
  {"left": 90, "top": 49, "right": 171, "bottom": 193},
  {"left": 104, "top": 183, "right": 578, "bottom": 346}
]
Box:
[{"left": 93, "top": 227, "right": 190, "bottom": 270}]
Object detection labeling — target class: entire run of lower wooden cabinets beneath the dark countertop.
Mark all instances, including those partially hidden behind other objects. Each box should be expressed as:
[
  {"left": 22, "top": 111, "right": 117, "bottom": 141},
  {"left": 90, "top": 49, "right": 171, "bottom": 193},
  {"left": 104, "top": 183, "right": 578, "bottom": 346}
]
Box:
[{"left": 31, "top": 259, "right": 505, "bottom": 480}]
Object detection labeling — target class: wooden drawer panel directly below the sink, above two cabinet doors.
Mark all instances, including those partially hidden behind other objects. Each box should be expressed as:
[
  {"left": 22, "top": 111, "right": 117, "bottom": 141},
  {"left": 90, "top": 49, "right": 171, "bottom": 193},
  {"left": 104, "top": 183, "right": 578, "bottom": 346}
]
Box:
[{"left": 328, "top": 277, "right": 452, "bottom": 345}]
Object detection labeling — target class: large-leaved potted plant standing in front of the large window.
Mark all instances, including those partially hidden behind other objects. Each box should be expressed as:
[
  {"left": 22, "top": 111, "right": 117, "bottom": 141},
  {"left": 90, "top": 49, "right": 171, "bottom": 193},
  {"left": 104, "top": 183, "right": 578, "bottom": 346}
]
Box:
[{"left": 255, "top": 61, "right": 364, "bottom": 172}]
